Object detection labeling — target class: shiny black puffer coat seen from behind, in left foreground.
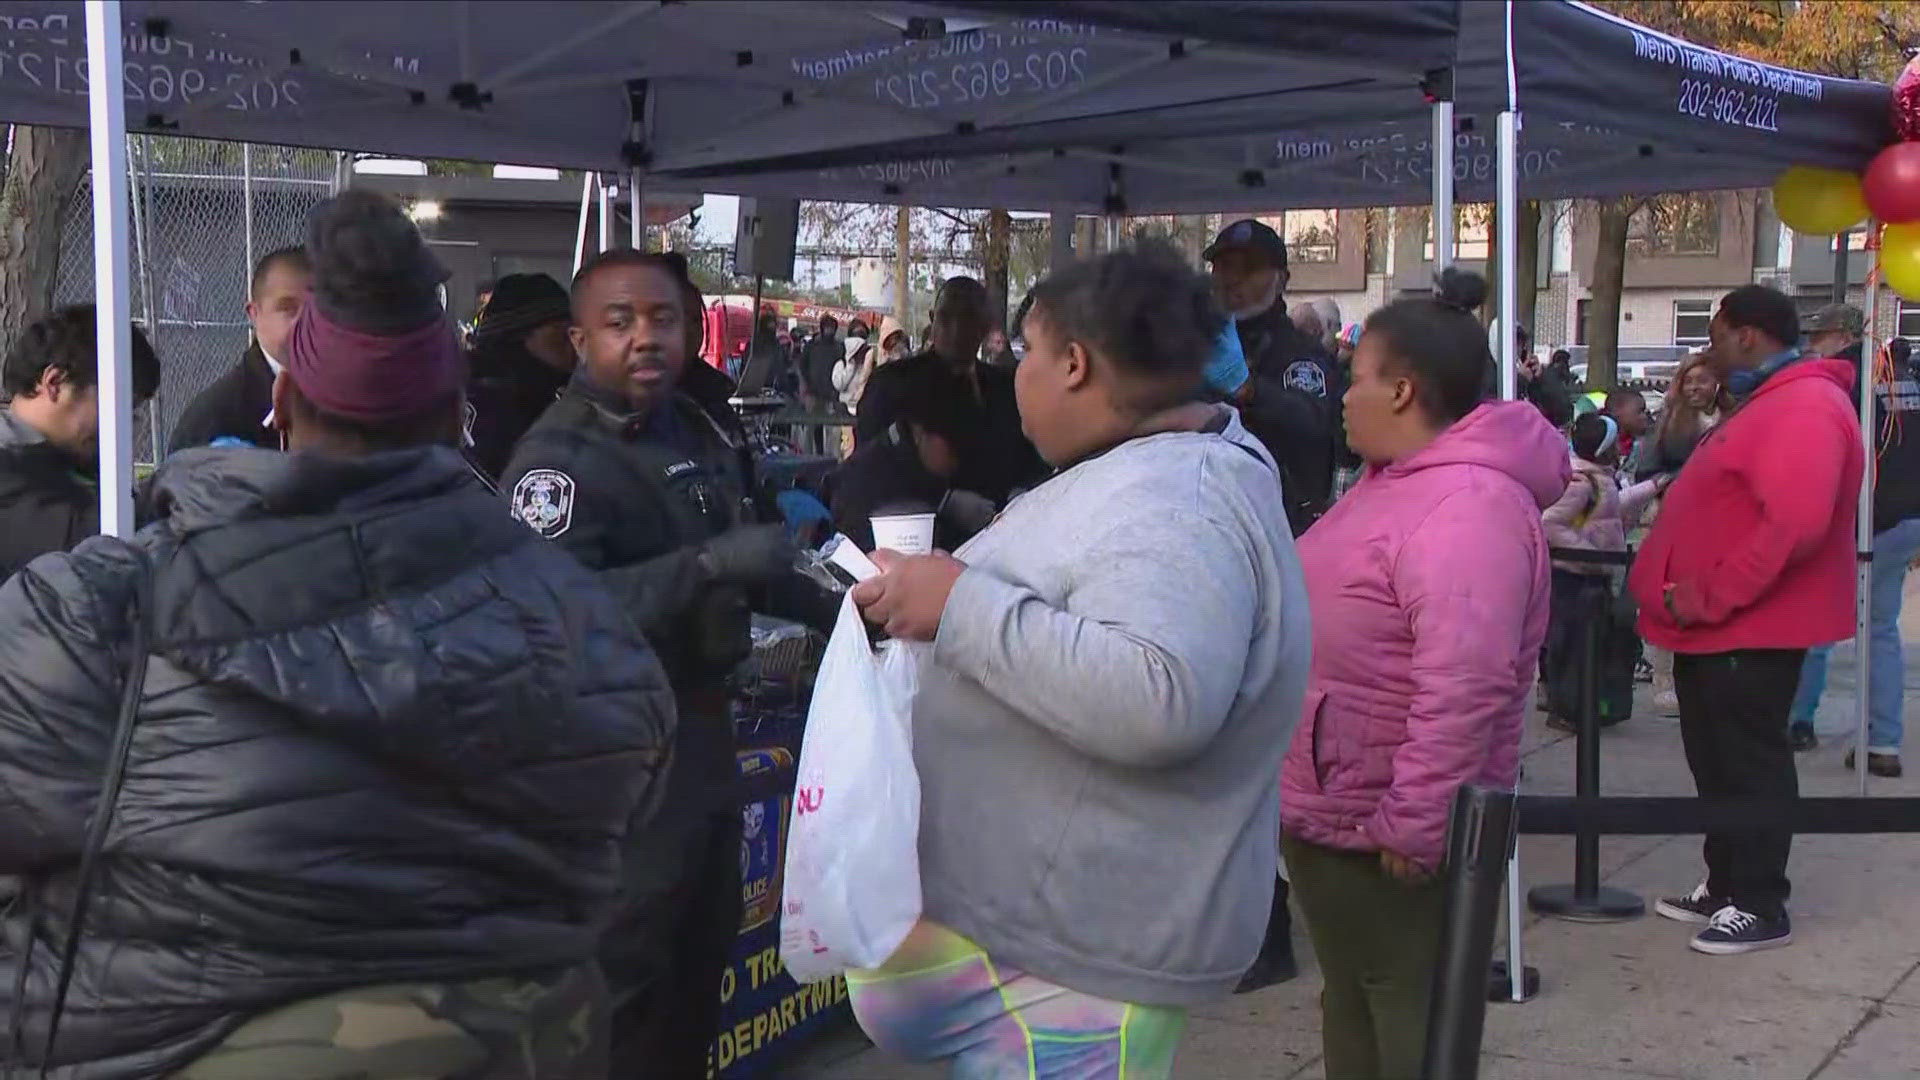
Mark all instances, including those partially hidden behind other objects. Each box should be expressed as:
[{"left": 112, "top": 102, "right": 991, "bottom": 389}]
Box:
[{"left": 0, "top": 448, "right": 674, "bottom": 1080}]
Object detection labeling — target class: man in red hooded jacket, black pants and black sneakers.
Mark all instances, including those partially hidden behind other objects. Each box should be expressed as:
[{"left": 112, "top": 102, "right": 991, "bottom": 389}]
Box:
[{"left": 1630, "top": 284, "right": 1864, "bottom": 955}]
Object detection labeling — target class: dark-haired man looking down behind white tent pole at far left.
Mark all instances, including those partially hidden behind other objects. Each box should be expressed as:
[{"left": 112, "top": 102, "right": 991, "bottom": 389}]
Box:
[{"left": 0, "top": 304, "right": 159, "bottom": 578}]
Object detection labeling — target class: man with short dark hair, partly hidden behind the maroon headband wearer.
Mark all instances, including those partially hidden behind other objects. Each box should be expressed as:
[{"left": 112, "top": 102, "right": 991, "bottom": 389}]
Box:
[{"left": 167, "top": 246, "right": 313, "bottom": 454}]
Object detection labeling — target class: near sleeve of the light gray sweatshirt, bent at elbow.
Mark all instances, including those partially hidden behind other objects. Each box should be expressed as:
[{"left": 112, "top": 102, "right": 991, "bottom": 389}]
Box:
[{"left": 933, "top": 507, "right": 1260, "bottom": 769}]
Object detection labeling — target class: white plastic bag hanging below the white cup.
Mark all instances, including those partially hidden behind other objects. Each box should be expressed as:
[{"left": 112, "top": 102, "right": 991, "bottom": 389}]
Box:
[{"left": 780, "top": 598, "right": 920, "bottom": 982}]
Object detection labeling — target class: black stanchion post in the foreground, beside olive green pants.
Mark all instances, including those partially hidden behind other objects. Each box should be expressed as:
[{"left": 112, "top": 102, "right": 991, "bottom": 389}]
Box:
[{"left": 1421, "top": 788, "right": 1517, "bottom": 1080}]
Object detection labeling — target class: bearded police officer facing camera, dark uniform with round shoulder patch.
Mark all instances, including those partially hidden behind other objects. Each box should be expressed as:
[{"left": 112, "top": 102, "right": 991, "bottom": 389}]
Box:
[{"left": 501, "top": 250, "right": 793, "bottom": 1080}]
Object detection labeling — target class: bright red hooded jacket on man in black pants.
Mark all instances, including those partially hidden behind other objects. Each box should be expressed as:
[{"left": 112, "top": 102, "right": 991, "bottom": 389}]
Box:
[{"left": 1628, "top": 359, "right": 1866, "bottom": 653}]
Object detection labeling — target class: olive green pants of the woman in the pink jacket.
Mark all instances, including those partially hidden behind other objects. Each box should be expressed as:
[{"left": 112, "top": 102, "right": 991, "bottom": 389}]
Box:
[{"left": 1281, "top": 836, "right": 1446, "bottom": 1080}]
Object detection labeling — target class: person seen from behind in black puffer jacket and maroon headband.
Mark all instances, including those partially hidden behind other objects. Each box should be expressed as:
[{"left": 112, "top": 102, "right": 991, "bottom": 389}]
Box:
[{"left": 0, "top": 192, "right": 674, "bottom": 1080}]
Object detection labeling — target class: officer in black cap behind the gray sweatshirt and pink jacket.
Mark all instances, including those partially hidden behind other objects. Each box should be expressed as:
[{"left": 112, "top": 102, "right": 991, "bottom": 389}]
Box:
[{"left": 1206, "top": 217, "right": 1346, "bottom": 536}]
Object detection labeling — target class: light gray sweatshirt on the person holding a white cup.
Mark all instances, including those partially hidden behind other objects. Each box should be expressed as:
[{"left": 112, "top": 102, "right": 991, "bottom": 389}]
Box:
[{"left": 914, "top": 413, "right": 1311, "bottom": 1005}]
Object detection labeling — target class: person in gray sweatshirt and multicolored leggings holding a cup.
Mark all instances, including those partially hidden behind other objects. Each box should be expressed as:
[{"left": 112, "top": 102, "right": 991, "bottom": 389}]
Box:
[{"left": 849, "top": 248, "right": 1309, "bottom": 1080}]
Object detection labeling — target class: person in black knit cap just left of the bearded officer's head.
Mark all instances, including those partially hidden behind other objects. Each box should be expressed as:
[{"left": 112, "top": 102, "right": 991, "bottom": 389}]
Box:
[{"left": 467, "top": 273, "right": 574, "bottom": 477}]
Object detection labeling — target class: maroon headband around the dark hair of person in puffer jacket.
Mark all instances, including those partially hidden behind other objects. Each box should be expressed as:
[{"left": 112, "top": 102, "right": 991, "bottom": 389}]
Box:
[{"left": 286, "top": 304, "right": 467, "bottom": 423}]
